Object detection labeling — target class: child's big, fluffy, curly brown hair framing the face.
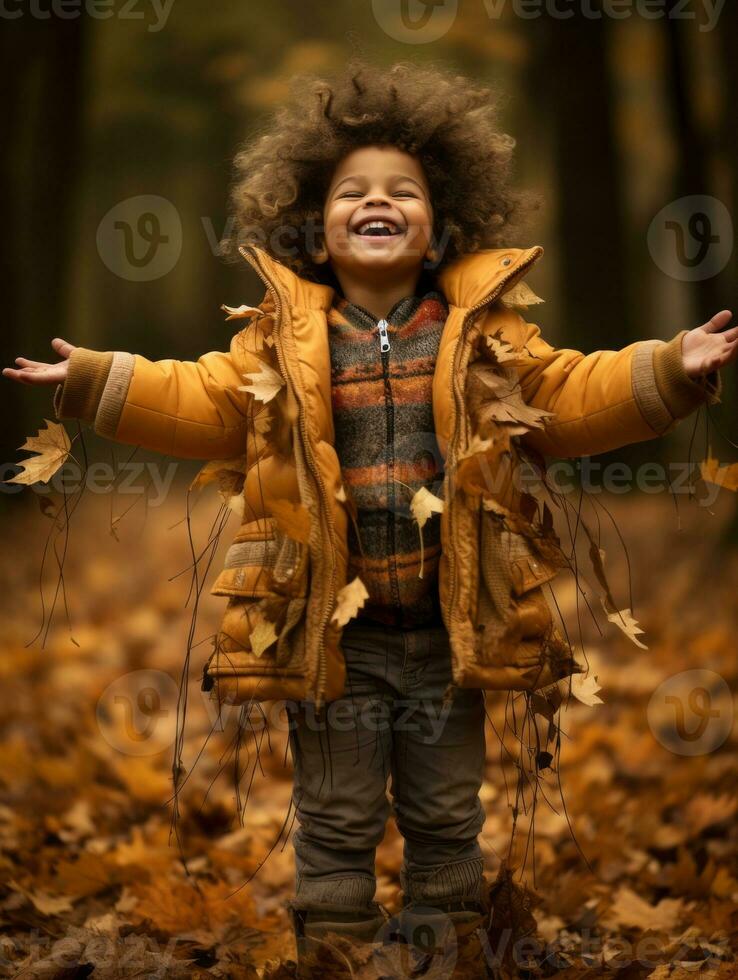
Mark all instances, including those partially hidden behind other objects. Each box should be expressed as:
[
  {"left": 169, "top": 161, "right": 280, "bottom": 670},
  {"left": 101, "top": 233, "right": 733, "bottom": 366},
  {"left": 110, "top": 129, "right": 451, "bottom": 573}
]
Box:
[{"left": 221, "top": 57, "right": 540, "bottom": 282}]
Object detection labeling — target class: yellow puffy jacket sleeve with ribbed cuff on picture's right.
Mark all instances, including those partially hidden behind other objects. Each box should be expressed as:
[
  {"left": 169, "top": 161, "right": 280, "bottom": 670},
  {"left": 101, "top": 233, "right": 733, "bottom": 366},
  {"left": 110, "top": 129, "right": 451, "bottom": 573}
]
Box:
[{"left": 517, "top": 323, "right": 722, "bottom": 458}]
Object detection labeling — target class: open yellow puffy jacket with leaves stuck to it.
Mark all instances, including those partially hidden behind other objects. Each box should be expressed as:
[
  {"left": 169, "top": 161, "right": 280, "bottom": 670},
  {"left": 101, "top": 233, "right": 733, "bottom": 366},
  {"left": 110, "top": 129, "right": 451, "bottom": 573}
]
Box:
[{"left": 54, "top": 245, "right": 721, "bottom": 706}]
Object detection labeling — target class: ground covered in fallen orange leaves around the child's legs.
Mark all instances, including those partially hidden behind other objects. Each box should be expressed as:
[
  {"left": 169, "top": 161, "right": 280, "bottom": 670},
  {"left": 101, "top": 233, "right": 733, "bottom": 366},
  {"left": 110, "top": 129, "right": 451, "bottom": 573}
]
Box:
[{"left": 0, "top": 474, "right": 738, "bottom": 980}]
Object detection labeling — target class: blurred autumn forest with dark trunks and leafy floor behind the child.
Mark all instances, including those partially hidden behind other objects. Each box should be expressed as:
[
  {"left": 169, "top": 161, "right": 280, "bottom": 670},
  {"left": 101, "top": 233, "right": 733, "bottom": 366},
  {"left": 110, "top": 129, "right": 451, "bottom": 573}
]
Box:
[{"left": 0, "top": 0, "right": 738, "bottom": 980}]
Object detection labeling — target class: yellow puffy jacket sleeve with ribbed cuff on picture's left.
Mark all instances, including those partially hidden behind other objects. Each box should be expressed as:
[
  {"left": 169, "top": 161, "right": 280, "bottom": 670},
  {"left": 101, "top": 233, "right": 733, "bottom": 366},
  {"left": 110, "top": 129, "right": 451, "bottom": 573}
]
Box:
[{"left": 54, "top": 335, "right": 251, "bottom": 459}]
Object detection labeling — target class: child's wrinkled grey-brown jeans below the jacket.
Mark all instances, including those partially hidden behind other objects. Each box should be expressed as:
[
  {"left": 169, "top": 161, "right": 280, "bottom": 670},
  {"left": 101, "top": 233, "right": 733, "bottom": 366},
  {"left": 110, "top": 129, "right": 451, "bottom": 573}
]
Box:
[{"left": 287, "top": 621, "right": 485, "bottom": 906}]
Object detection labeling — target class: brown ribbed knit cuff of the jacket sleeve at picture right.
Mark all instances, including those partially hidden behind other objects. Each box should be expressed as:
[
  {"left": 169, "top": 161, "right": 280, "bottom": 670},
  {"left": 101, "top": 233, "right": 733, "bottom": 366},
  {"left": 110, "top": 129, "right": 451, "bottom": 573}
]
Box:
[{"left": 632, "top": 330, "right": 722, "bottom": 435}]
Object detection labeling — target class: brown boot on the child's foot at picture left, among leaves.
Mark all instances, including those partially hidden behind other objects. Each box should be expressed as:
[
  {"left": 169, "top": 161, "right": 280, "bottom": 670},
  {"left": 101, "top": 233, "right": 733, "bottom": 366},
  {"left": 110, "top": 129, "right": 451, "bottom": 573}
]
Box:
[{"left": 287, "top": 899, "right": 389, "bottom": 980}]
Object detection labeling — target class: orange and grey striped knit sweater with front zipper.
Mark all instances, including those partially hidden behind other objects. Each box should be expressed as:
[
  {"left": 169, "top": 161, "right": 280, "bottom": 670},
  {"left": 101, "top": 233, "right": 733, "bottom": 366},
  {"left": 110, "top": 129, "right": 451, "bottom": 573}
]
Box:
[{"left": 328, "top": 289, "right": 448, "bottom": 627}]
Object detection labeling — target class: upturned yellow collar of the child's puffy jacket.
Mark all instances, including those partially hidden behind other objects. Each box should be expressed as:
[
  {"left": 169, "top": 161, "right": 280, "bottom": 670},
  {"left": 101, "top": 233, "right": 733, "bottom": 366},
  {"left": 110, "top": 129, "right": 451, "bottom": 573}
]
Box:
[{"left": 239, "top": 245, "right": 543, "bottom": 312}]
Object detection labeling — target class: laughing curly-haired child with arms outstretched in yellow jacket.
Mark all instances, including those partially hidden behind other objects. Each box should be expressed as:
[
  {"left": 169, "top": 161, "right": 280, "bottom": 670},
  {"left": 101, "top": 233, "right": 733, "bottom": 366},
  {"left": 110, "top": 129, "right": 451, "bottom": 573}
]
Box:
[{"left": 3, "top": 64, "right": 738, "bottom": 975}]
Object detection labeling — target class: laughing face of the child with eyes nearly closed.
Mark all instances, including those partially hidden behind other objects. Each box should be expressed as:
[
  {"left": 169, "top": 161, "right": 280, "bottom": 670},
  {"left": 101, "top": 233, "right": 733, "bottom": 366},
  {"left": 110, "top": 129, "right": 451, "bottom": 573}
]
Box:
[{"left": 323, "top": 146, "right": 433, "bottom": 277}]
